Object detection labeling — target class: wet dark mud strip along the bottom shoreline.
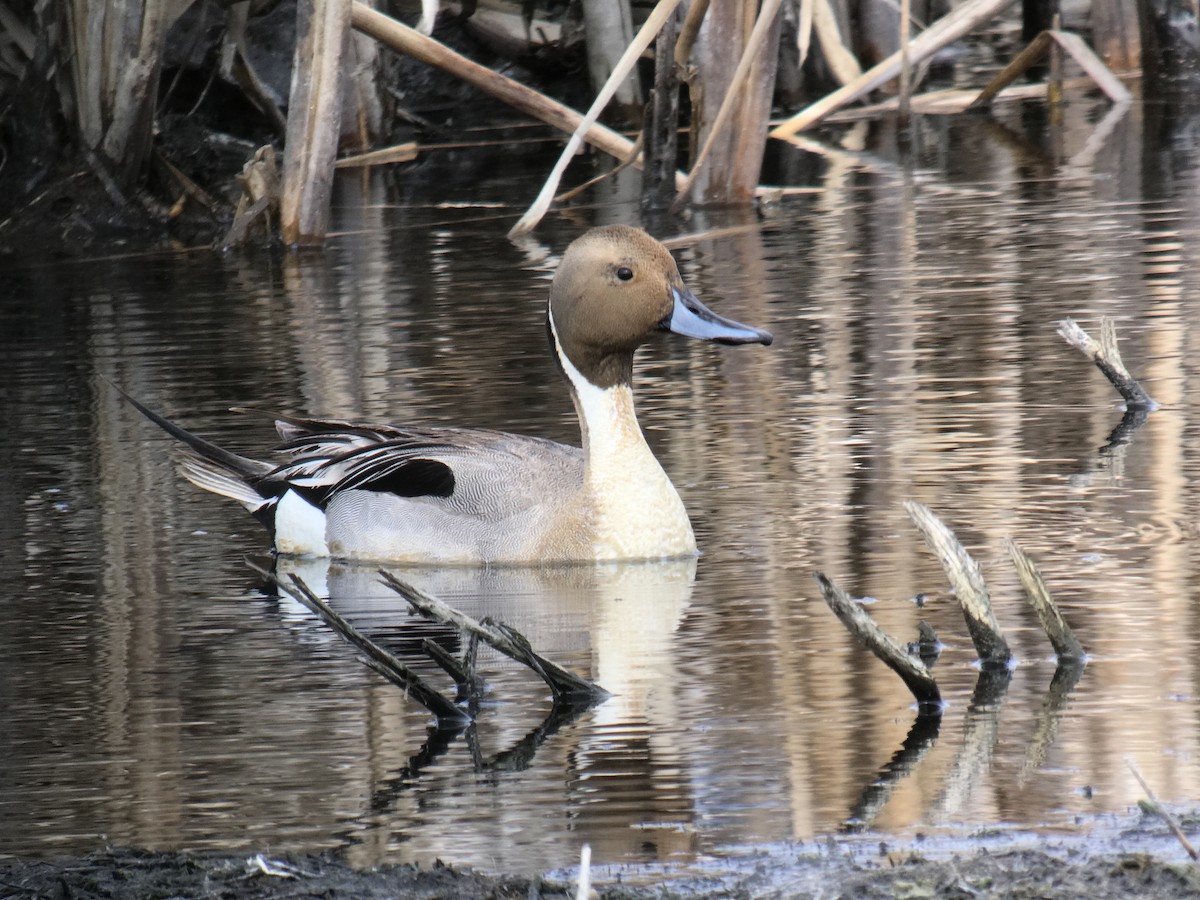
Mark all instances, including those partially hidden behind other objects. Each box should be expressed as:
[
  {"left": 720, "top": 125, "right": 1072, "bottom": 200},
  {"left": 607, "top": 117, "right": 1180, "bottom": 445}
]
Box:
[{"left": 0, "top": 817, "right": 1200, "bottom": 900}]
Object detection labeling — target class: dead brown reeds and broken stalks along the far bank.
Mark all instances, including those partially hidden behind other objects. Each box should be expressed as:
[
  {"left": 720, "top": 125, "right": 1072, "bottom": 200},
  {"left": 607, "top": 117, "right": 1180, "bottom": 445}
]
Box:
[{"left": 0, "top": 0, "right": 1161, "bottom": 246}]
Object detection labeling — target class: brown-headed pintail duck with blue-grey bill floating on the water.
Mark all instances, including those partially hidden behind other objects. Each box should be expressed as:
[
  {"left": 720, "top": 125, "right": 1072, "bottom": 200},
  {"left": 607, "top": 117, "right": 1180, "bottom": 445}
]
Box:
[{"left": 121, "top": 224, "right": 773, "bottom": 565}]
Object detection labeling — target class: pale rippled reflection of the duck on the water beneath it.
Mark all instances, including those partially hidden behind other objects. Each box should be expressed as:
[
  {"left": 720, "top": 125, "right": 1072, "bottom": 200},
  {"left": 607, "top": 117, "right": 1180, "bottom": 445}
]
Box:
[{"left": 277, "top": 557, "right": 697, "bottom": 858}]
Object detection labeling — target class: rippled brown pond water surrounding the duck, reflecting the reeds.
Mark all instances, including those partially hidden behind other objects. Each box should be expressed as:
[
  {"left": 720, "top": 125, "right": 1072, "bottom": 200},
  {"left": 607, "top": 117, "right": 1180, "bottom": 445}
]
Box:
[{"left": 0, "top": 95, "right": 1200, "bottom": 870}]
